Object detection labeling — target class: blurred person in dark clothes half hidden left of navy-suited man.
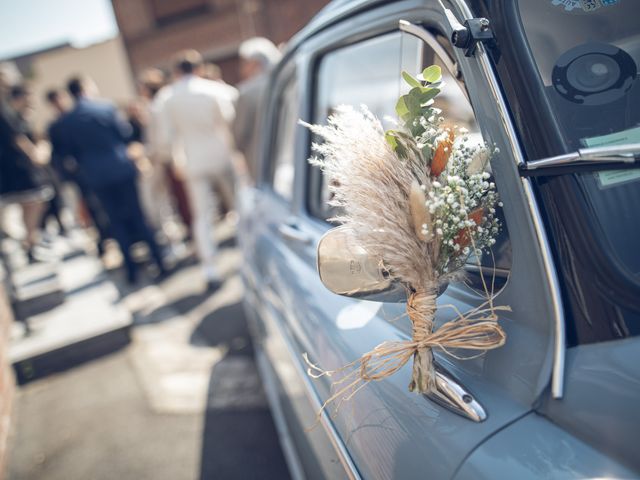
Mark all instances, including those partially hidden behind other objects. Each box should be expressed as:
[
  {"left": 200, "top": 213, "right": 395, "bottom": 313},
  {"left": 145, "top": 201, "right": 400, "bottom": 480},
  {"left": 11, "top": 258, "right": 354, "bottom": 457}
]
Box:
[{"left": 45, "top": 89, "right": 108, "bottom": 251}]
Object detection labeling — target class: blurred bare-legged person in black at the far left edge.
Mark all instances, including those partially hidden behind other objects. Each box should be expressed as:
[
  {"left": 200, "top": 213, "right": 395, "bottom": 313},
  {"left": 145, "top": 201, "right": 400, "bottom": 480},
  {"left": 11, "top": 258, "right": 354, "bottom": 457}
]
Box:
[{"left": 0, "top": 85, "right": 52, "bottom": 261}]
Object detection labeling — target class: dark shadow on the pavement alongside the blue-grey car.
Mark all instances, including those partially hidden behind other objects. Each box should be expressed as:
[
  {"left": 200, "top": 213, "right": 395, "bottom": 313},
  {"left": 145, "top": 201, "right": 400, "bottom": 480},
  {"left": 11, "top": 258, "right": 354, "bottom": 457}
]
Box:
[{"left": 196, "top": 303, "right": 289, "bottom": 480}]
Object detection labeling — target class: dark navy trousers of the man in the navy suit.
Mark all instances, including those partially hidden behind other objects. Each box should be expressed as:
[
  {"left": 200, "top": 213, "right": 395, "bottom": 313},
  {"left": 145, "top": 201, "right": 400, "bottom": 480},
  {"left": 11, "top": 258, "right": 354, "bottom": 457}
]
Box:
[{"left": 95, "top": 178, "right": 164, "bottom": 281}]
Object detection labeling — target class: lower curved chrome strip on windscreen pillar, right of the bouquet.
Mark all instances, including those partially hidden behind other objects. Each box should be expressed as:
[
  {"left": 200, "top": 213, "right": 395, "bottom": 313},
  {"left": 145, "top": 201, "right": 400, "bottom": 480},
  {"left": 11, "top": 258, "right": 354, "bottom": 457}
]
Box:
[{"left": 522, "top": 177, "right": 566, "bottom": 399}]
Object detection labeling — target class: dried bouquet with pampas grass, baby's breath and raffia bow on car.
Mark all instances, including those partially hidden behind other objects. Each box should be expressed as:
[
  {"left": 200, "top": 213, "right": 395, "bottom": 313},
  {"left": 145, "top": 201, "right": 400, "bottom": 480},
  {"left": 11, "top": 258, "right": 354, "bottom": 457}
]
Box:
[{"left": 304, "top": 66, "right": 508, "bottom": 412}]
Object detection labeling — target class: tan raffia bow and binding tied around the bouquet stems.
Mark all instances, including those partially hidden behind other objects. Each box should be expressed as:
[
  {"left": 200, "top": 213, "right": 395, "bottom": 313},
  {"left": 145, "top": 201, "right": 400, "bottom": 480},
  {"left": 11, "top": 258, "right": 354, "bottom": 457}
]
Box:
[{"left": 303, "top": 290, "right": 510, "bottom": 426}]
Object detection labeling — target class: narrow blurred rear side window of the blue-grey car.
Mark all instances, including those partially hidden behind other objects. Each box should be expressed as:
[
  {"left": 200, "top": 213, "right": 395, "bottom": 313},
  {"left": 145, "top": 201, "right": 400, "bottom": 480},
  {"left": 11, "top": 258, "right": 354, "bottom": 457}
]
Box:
[{"left": 270, "top": 74, "right": 299, "bottom": 201}]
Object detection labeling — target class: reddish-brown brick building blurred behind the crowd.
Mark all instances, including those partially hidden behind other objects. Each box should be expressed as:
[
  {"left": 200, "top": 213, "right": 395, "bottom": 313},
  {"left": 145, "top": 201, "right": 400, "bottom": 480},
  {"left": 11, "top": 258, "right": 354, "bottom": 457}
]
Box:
[{"left": 112, "top": 0, "right": 328, "bottom": 83}]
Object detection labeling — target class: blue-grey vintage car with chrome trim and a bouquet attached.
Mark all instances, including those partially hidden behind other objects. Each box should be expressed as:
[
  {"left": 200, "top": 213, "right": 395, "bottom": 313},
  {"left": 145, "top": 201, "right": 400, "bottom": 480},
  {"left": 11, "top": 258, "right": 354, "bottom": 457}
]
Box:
[{"left": 239, "top": 0, "right": 640, "bottom": 479}]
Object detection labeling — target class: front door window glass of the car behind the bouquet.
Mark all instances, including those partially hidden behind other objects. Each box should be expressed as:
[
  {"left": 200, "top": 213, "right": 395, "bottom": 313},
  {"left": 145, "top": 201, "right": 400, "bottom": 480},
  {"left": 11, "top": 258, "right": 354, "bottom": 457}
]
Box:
[{"left": 307, "top": 32, "right": 511, "bottom": 289}]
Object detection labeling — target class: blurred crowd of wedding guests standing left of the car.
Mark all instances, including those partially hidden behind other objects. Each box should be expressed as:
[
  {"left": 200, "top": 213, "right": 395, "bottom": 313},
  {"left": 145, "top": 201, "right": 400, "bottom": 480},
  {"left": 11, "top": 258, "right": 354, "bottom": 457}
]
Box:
[{"left": 0, "top": 38, "right": 280, "bottom": 288}]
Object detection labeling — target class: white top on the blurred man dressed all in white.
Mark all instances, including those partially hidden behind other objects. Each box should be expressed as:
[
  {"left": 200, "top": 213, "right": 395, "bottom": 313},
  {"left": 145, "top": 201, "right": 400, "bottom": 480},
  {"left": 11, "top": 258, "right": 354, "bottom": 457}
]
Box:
[{"left": 158, "top": 75, "right": 238, "bottom": 176}]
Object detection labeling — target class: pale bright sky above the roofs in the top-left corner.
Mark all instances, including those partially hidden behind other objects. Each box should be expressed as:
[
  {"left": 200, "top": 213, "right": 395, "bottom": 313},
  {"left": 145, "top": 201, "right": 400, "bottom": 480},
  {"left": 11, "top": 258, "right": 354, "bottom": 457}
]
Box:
[{"left": 0, "top": 0, "right": 118, "bottom": 59}]
